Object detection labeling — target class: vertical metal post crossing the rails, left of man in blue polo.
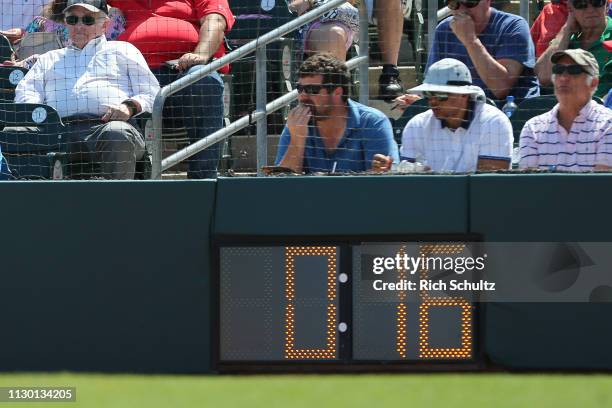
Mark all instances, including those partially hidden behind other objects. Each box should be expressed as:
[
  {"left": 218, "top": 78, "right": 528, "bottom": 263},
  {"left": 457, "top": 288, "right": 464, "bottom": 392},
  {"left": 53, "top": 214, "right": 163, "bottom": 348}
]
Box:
[{"left": 255, "top": 45, "right": 268, "bottom": 177}]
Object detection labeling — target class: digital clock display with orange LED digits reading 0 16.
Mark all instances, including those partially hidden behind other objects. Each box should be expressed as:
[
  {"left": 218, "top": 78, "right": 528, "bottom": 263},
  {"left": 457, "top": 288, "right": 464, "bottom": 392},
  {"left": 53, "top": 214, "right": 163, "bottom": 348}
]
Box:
[{"left": 218, "top": 242, "right": 475, "bottom": 364}]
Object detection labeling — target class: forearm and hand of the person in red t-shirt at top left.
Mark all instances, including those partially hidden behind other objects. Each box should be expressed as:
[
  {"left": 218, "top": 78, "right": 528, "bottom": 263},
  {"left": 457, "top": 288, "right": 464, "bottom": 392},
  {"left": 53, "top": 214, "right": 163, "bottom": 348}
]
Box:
[{"left": 178, "top": 13, "right": 227, "bottom": 71}]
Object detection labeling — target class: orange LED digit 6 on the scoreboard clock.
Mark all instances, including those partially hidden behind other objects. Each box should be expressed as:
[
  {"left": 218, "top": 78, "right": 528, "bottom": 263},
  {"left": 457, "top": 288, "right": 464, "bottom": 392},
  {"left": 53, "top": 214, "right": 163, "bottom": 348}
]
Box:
[{"left": 419, "top": 244, "right": 473, "bottom": 359}]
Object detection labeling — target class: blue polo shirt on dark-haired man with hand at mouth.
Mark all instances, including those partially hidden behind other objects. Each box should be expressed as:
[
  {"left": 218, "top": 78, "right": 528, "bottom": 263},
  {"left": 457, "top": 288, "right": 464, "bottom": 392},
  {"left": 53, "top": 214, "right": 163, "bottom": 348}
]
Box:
[{"left": 276, "top": 99, "right": 398, "bottom": 173}]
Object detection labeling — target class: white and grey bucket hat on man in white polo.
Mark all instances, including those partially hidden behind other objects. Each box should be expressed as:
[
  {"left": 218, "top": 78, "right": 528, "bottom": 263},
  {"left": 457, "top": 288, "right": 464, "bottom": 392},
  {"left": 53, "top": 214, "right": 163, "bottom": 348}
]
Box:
[{"left": 409, "top": 58, "right": 482, "bottom": 95}]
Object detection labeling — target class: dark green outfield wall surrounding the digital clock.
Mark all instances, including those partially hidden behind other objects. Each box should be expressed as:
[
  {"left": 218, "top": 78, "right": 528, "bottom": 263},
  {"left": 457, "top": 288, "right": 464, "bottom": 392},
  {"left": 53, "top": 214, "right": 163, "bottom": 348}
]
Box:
[{"left": 0, "top": 175, "right": 612, "bottom": 373}]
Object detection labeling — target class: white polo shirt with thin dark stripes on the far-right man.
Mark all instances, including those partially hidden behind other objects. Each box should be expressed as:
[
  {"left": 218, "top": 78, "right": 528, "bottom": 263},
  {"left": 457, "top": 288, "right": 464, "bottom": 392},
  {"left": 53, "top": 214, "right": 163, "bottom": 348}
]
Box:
[{"left": 519, "top": 101, "right": 612, "bottom": 171}]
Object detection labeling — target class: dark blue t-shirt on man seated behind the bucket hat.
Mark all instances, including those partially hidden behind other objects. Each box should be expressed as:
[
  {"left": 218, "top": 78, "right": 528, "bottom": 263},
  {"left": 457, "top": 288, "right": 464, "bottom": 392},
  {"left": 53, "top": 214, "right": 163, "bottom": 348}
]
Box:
[{"left": 427, "top": 7, "right": 540, "bottom": 106}]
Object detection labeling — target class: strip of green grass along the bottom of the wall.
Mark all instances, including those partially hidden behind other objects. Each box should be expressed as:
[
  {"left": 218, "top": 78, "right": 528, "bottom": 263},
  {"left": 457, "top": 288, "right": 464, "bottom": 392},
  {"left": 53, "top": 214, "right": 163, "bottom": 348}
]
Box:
[{"left": 0, "top": 373, "right": 612, "bottom": 408}]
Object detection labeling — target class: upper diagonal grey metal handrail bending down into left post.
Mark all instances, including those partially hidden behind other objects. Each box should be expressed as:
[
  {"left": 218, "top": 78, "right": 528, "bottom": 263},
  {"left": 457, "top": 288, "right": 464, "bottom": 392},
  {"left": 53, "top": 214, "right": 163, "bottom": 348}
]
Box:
[{"left": 146, "top": 0, "right": 356, "bottom": 179}]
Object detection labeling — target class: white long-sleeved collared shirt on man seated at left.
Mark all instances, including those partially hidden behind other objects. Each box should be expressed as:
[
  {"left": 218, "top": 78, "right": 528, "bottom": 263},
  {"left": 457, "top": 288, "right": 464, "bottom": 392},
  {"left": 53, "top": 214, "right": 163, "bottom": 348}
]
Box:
[{"left": 15, "top": 36, "right": 159, "bottom": 118}]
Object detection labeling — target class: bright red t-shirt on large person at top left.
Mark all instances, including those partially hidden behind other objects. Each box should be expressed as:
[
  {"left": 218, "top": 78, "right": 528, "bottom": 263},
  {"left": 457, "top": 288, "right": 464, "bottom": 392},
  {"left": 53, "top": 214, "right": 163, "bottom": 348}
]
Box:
[{"left": 108, "top": 0, "right": 234, "bottom": 68}]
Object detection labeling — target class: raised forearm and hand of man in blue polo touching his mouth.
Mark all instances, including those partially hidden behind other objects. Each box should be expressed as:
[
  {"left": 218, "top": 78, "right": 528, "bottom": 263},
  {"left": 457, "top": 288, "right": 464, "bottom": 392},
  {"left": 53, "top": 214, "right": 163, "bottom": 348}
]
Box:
[{"left": 277, "top": 105, "right": 311, "bottom": 173}]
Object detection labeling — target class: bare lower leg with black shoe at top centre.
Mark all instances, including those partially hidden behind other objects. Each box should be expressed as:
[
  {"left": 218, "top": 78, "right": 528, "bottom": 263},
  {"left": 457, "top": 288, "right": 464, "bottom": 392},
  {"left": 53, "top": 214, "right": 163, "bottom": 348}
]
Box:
[{"left": 366, "top": 0, "right": 404, "bottom": 102}]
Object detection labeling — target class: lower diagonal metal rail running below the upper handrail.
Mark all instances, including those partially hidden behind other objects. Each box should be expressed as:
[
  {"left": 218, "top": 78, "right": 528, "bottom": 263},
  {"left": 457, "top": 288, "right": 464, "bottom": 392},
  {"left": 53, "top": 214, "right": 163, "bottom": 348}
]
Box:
[{"left": 161, "top": 56, "right": 368, "bottom": 171}]
